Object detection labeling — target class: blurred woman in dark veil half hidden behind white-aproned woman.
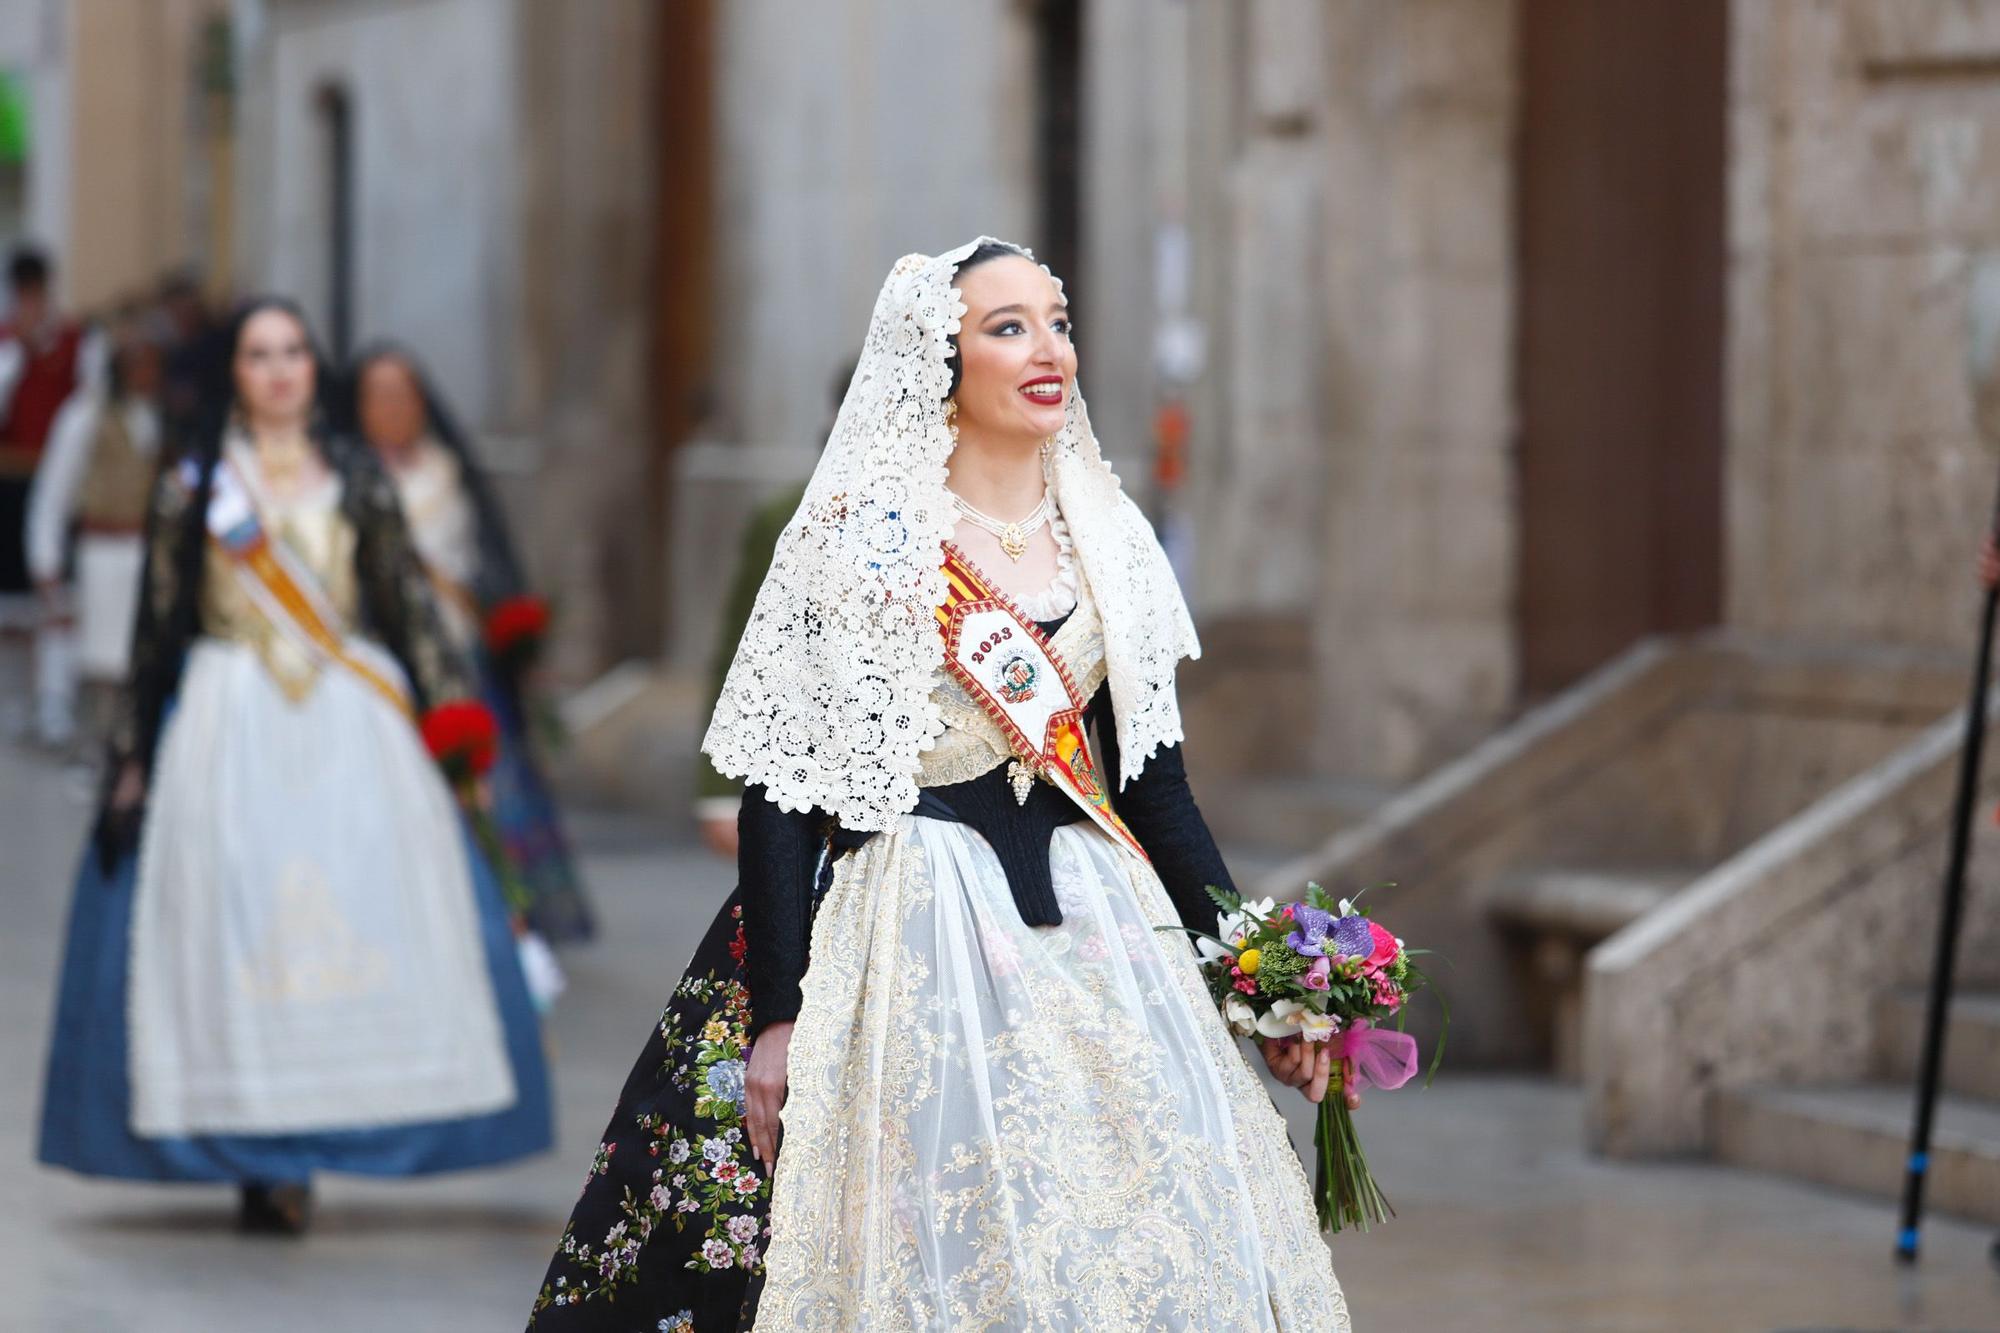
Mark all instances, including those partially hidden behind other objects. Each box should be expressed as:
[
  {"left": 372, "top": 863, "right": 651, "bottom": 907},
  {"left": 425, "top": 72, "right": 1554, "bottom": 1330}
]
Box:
[{"left": 346, "top": 344, "right": 592, "bottom": 941}]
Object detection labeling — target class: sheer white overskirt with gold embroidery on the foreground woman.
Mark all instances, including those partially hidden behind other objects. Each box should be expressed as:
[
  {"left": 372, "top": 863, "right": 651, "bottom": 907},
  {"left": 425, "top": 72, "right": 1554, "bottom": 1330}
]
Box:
[{"left": 758, "top": 817, "right": 1348, "bottom": 1331}]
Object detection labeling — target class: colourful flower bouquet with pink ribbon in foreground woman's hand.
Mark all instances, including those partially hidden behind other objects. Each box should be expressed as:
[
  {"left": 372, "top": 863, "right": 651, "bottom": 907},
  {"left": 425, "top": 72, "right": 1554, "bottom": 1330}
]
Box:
[{"left": 1194, "top": 885, "right": 1450, "bottom": 1231}]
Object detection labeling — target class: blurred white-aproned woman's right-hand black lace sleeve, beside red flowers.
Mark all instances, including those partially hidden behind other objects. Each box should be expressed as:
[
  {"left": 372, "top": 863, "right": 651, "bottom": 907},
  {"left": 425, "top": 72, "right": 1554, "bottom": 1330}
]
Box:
[{"left": 340, "top": 444, "right": 478, "bottom": 715}]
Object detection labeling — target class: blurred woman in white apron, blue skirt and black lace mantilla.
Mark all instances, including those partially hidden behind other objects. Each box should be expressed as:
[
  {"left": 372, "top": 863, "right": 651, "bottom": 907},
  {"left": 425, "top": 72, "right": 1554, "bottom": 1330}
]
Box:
[{"left": 40, "top": 300, "right": 550, "bottom": 1233}]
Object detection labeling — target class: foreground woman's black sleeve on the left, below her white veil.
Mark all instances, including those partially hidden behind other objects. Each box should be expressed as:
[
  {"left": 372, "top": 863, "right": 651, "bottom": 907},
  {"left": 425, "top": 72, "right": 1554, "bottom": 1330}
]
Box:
[{"left": 736, "top": 787, "right": 826, "bottom": 1035}]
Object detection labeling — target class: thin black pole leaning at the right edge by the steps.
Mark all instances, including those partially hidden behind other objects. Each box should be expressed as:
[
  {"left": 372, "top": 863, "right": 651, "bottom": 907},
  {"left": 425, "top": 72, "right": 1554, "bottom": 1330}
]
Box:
[{"left": 1896, "top": 472, "right": 2000, "bottom": 1263}]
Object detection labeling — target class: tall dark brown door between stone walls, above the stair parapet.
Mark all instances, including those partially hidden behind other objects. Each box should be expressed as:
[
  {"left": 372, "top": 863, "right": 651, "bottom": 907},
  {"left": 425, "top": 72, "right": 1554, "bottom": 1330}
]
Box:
[{"left": 1518, "top": 0, "right": 1728, "bottom": 697}]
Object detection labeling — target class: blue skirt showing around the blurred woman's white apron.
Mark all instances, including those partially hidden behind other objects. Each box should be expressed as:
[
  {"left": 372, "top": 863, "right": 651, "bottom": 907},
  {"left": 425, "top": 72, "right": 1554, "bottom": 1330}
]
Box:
[{"left": 36, "top": 835, "right": 554, "bottom": 1183}]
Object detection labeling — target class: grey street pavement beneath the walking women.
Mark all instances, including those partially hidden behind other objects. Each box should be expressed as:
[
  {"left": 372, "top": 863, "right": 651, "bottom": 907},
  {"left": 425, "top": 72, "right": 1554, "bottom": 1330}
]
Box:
[{"left": 0, "top": 704, "right": 2000, "bottom": 1333}]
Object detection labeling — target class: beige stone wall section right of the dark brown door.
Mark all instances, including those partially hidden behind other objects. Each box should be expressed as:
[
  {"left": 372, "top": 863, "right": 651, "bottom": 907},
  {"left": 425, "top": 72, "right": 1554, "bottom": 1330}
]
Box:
[{"left": 1728, "top": 0, "right": 2000, "bottom": 648}]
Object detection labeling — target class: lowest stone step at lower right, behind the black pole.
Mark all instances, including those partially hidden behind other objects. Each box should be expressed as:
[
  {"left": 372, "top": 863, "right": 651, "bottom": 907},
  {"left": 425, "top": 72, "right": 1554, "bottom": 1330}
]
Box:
[{"left": 1714, "top": 1083, "right": 2000, "bottom": 1235}]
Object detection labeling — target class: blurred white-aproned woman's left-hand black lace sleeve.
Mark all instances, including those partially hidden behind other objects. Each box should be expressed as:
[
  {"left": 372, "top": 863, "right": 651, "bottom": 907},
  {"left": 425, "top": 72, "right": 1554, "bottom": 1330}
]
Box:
[{"left": 110, "top": 466, "right": 202, "bottom": 783}]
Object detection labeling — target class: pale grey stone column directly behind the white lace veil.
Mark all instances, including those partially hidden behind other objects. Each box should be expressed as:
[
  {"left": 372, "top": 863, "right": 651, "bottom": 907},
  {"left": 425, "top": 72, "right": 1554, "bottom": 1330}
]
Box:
[{"left": 664, "top": 0, "right": 1036, "bottom": 669}]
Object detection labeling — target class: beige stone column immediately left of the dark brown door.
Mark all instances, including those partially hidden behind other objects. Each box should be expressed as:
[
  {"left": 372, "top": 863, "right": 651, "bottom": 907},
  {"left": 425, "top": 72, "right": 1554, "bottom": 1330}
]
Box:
[{"left": 1312, "top": 0, "right": 1514, "bottom": 781}]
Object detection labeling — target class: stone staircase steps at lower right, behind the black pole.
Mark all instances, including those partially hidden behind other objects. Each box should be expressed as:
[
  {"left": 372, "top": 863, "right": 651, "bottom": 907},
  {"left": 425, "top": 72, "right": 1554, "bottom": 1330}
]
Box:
[{"left": 1712, "top": 991, "right": 2000, "bottom": 1225}]
